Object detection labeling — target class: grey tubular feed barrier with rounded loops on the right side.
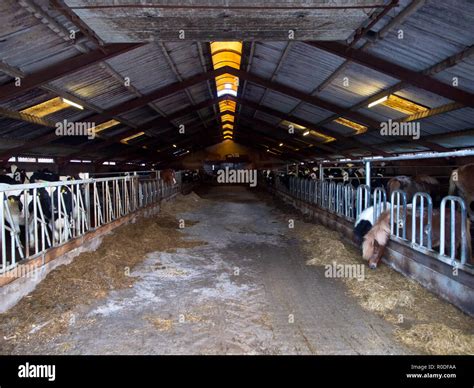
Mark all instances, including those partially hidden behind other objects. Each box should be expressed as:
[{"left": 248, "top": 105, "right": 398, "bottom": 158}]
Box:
[{"left": 275, "top": 176, "right": 472, "bottom": 272}]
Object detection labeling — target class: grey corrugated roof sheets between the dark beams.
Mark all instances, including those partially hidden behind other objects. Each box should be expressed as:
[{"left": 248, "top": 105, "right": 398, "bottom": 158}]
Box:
[{"left": 0, "top": 0, "right": 474, "bottom": 161}]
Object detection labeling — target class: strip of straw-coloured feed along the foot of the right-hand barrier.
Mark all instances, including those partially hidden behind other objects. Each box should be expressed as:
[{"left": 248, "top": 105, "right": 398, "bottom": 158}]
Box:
[{"left": 262, "top": 196, "right": 474, "bottom": 355}]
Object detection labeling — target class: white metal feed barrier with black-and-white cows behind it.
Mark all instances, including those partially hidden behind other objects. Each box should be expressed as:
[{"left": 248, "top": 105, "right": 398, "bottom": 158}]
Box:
[{"left": 0, "top": 172, "right": 181, "bottom": 274}]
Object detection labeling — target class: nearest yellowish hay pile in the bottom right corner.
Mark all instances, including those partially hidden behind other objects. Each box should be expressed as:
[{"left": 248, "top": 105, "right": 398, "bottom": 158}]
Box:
[{"left": 395, "top": 323, "right": 474, "bottom": 355}]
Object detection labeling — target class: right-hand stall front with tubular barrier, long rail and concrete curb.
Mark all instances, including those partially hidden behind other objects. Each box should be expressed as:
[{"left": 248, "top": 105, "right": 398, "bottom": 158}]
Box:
[{"left": 268, "top": 151, "right": 474, "bottom": 315}]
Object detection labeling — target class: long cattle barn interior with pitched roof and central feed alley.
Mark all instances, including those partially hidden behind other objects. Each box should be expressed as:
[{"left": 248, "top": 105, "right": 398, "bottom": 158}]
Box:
[{"left": 0, "top": 0, "right": 474, "bottom": 354}]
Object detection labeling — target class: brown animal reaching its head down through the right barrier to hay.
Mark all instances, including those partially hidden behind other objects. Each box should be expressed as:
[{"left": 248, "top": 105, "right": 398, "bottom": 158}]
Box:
[{"left": 362, "top": 208, "right": 473, "bottom": 269}]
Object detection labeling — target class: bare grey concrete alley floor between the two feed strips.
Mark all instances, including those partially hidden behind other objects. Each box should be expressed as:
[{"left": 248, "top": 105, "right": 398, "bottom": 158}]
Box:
[{"left": 37, "top": 187, "right": 409, "bottom": 354}]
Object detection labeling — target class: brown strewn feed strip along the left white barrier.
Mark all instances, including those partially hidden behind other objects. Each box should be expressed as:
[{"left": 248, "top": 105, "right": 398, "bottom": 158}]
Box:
[{"left": 0, "top": 192, "right": 206, "bottom": 354}]
